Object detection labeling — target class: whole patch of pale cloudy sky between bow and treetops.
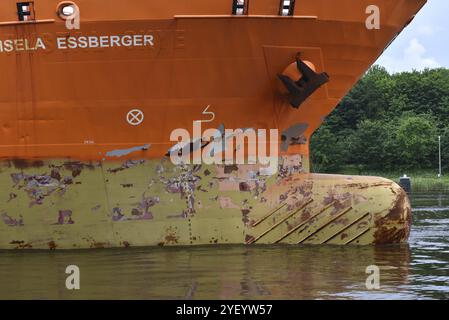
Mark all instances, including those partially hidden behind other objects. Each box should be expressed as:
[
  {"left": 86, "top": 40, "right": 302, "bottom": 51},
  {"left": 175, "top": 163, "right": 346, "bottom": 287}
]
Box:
[{"left": 377, "top": 0, "right": 449, "bottom": 72}]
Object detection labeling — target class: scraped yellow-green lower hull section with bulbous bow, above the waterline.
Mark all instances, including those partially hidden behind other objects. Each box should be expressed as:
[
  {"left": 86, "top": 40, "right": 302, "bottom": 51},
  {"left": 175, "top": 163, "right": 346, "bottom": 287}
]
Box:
[{"left": 0, "top": 157, "right": 411, "bottom": 250}]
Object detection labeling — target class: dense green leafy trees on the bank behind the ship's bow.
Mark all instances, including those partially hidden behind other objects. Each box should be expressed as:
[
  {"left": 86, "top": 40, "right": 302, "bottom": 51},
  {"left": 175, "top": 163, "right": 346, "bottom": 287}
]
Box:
[{"left": 311, "top": 66, "right": 449, "bottom": 172}]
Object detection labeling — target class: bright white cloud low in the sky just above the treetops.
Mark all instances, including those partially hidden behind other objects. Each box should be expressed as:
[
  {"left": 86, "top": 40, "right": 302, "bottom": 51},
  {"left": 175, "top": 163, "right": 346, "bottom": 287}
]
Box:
[{"left": 377, "top": 37, "right": 440, "bottom": 73}]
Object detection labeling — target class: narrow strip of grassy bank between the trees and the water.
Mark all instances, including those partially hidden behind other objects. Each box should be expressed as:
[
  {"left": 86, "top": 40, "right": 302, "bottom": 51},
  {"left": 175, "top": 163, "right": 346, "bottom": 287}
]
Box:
[{"left": 330, "top": 167, "right": 449, "bottom": 193}]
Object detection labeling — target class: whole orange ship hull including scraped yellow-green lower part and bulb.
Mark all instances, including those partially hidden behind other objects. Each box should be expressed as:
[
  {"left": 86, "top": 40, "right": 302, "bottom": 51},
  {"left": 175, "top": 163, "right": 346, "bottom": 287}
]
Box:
[{"left": 0, "top": 0, "right": 425, "bottom": 248}]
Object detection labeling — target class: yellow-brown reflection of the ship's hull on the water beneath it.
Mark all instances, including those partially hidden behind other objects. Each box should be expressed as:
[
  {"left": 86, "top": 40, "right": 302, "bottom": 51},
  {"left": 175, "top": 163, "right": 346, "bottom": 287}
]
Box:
[{"left": 0, "top": 246, "right": 410, "bottom": 299}]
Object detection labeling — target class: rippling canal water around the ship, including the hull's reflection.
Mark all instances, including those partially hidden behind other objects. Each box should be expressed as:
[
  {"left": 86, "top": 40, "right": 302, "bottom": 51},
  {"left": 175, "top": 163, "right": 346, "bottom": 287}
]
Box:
[{"left": 0, "top": 194, "right": 449, "bottom": 299}]
